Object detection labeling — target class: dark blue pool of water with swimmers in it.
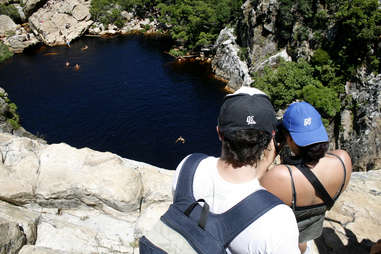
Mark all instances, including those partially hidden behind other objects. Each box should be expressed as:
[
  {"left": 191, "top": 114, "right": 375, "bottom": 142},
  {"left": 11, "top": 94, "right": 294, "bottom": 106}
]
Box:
[{"left": 0, "top": 37, "right": 225, "bottom": 169}]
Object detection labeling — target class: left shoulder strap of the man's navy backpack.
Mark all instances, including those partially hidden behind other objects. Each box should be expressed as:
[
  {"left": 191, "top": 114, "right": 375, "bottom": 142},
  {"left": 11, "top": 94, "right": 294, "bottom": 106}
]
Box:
[{"left": 173, "top": 153, "right": 208, "bottom": 202}]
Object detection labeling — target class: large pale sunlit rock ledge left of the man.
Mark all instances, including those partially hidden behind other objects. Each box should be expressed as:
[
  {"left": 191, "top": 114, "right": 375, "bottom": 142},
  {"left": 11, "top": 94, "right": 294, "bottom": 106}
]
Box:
[{"left": 0, "top": 134, "right": 173, "bottom": 254}]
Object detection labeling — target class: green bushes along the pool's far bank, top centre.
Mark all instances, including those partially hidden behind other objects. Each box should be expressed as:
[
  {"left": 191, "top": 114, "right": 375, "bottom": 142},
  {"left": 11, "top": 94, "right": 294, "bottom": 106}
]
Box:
[{"left": 90, "top": 0, "right": 243, "bottom": 50}]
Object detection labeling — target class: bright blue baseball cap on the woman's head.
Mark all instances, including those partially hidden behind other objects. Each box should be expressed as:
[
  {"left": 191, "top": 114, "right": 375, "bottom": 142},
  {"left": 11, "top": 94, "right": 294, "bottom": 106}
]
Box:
[{"left": 283, "top": 102, "right": 328, "bottom": 146}]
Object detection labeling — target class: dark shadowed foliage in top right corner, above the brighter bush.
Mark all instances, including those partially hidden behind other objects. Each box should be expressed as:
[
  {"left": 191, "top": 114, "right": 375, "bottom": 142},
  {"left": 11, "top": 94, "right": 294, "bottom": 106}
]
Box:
[{"left": 275, "top": 0, "right": 381, "bottom": 77}]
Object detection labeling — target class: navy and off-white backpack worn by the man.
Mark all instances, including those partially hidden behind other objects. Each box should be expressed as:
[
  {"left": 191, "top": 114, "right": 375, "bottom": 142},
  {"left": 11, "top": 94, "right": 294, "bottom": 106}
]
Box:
[{"left": 139, "top": 153, "right": 283, "bottom": 254}]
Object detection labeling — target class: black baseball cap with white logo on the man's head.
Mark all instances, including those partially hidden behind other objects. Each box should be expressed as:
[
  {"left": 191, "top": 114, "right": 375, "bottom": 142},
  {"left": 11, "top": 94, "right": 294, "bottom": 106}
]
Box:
[{"left": 218, "top": 87, "right": 277, "bottom": 139}]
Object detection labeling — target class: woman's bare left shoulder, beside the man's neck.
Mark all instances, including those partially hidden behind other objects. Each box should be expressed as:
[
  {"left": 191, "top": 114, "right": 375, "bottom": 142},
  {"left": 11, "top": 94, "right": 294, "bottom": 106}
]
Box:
[{"left": 260, "top": 165, "right": 292, "bottom": 205}]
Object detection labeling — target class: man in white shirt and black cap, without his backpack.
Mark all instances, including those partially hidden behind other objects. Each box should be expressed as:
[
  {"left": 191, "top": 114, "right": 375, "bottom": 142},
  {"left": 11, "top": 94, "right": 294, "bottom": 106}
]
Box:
[{"left": 173, "top": 87, "right": 300, "bottom": 254}]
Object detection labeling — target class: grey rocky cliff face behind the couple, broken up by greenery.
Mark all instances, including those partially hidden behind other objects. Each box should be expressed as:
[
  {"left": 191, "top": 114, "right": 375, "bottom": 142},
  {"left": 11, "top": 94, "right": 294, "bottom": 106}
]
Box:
[{"left": 212, "top": 0, "right": 381, "bottom": 171}]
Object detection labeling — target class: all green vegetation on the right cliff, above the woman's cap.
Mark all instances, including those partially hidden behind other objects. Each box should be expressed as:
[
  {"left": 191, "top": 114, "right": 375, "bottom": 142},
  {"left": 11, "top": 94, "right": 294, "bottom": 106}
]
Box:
[{"left": 249, "top": 0, "right": 381, "bottom": 120}]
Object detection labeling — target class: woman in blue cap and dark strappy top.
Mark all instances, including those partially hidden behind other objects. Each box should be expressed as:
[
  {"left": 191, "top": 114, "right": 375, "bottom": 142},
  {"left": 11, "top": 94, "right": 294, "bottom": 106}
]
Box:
[{"left": 261, "top": 102, "right": 352, "bottom": 254}]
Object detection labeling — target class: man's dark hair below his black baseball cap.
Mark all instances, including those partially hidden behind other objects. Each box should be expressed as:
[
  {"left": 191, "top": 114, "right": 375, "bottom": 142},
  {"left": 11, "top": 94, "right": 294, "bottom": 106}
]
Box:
[{"left": 221, "top": 129, "right": 272, "bottom": 168}]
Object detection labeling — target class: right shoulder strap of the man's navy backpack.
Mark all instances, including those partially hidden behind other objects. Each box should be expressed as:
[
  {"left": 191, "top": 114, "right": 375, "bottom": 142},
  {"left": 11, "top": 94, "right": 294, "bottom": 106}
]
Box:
[{"left": 219, "top": 189, "right": 283, "bottom": 248}]
